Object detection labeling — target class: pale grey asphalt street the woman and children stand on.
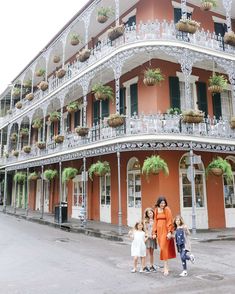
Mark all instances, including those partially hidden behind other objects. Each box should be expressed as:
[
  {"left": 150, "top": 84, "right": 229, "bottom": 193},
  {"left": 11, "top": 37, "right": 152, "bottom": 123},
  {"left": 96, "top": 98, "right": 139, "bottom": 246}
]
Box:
[{"left": 0, "top": 214, "right": 235, "bottom": 294}]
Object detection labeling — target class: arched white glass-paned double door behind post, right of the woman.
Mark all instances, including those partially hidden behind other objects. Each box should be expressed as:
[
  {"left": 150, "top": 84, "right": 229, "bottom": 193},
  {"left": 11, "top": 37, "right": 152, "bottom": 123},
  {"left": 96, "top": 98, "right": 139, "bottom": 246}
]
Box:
[{"left": 180, "top": 156, "right": 208, "bottom": 229}]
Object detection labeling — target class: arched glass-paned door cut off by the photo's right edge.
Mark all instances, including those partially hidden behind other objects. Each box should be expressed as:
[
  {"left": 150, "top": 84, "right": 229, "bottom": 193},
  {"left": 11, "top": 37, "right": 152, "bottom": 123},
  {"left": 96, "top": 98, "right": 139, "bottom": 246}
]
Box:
[{"left": 223, "top": 157, "right": 235, "bottom": 228}]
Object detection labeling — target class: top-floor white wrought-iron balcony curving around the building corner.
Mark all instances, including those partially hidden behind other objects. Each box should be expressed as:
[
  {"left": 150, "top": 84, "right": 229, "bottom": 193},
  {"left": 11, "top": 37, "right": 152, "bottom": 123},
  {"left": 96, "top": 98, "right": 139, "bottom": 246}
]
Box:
[{"left": 0, "top": 20, "right": 235, "bottom": 127}]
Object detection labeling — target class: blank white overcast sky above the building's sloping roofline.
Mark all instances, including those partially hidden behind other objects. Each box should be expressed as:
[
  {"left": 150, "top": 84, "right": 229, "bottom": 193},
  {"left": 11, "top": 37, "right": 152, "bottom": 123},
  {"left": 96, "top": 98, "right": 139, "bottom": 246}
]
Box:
[{"left": 0, "top": 0, "right": 88, "bottom": 95}]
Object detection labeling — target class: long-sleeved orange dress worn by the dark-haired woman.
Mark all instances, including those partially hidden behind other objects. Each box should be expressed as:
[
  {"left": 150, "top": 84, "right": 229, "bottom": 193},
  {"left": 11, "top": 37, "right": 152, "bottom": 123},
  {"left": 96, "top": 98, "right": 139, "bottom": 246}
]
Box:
[{"left": 153, "top": 207, "right": 176, "bottom": 260}]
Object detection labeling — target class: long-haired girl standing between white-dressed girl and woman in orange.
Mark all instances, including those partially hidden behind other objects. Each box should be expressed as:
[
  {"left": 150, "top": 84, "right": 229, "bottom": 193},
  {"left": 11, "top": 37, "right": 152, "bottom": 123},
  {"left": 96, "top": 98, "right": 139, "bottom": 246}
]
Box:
[{"left": 144, "top": 208, "right": 157, "bottom": 272}]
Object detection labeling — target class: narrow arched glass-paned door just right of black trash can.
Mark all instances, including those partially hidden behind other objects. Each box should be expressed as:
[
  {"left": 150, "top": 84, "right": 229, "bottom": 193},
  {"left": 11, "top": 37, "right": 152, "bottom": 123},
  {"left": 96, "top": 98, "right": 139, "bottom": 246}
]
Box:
[{"left": 72, "top": 175, "right": 83, "bottom": 219}]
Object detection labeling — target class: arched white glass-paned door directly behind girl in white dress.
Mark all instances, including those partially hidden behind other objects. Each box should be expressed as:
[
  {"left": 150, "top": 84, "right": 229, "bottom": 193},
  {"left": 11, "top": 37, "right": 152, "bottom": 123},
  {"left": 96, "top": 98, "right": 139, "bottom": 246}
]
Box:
[{"left": 127, "top": 158, "right": 142, "bottom": 227}]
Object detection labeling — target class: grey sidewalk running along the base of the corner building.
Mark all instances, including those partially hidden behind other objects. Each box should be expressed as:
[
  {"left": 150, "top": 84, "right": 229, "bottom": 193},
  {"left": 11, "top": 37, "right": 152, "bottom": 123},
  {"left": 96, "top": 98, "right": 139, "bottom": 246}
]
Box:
[{"left": 0, "top": 206, "right": 235, "bottom": 243}]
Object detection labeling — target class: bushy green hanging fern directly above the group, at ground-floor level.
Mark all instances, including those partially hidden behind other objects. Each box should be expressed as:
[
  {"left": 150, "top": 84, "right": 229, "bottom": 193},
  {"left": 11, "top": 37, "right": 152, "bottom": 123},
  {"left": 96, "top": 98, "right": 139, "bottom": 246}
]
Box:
[{"left": 142, "top": 155, "right": 169, "bottom": 178}]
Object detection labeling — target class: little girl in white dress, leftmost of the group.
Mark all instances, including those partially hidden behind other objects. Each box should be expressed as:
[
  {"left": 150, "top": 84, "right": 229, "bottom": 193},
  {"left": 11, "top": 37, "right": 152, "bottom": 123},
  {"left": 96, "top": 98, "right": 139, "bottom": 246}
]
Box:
[{"left": 129, "top": 221, "right": 147, "bottom": 273}]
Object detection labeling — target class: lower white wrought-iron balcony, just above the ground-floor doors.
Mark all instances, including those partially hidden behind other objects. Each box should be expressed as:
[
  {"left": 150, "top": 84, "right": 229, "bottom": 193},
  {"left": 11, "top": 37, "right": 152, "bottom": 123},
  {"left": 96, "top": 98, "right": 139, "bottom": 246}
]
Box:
[{"left": 0, "top": 114, "right": 235, "bottom": 165}]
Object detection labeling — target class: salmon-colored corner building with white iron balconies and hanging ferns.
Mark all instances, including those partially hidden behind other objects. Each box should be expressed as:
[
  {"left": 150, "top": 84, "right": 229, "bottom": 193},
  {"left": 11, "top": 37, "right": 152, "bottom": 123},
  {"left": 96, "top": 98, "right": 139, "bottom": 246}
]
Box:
[{"left": 0, "top": 0, "right": 235, "bottom": 229}]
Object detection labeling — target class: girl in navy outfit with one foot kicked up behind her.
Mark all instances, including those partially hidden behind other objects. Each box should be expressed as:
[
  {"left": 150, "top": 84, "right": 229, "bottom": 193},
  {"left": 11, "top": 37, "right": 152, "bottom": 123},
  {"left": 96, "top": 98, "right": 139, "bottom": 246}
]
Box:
[{"left": 174, "top": 215, "right": 195, "bottom": 277}]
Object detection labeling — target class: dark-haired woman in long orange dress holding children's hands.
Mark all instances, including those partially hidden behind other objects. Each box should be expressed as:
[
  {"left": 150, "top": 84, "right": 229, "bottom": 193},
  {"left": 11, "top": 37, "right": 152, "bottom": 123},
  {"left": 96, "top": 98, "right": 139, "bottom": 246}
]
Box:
[{"left": 153, "top": 196, "right": 176, "bottom": 276}]
